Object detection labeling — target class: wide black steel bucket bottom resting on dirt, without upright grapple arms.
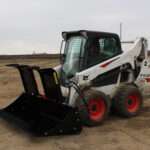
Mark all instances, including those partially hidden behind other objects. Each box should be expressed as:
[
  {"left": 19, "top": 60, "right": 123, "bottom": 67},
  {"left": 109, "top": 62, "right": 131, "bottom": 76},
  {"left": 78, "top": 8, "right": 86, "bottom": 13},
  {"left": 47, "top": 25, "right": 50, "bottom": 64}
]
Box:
[{"left": 1, "top": 94, "right": 82, "bottom": 136}]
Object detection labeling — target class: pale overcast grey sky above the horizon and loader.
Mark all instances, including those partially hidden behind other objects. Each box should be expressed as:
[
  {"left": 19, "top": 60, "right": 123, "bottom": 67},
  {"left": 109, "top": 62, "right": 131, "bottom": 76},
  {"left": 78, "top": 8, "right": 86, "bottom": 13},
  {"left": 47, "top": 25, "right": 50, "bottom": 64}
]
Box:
[{"left": 0, "top": 0, "right": 150, "bottom": 54}]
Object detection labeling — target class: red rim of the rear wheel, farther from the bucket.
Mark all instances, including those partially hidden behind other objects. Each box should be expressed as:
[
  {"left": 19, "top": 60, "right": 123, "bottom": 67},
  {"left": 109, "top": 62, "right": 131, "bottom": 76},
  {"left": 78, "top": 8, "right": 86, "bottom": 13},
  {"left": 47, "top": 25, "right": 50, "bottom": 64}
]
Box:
[{"left": 126, "top": 94, "right": 140, "bottom": 113}]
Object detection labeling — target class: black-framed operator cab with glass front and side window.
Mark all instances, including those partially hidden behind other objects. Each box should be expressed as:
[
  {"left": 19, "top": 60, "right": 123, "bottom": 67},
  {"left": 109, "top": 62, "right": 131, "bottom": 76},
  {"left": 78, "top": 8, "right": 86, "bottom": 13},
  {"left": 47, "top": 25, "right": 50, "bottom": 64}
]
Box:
[{"left": 61, "top": 30, "right": 122, "bottom": 82}]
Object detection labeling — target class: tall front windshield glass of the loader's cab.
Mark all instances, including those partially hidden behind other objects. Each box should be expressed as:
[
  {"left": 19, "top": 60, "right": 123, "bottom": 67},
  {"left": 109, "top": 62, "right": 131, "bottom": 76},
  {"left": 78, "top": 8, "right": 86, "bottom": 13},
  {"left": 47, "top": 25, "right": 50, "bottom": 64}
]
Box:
[{"left": 62, "top": 36, "right": 85, "bottom": 77}]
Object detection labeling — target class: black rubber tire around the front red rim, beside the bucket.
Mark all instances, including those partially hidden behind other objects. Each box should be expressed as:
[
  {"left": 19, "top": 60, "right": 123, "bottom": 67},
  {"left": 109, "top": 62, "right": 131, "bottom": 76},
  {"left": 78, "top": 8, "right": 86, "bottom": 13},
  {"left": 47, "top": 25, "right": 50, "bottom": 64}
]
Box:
[{"left": 76, "top": 89, "right": 110, "bottom": 127}]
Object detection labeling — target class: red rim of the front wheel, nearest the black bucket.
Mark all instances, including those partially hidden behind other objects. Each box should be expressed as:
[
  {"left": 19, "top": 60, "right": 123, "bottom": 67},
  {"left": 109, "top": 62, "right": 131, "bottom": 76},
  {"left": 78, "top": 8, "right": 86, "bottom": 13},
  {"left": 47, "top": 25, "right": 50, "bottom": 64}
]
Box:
[{"left": 88, "top": 99, "right": 106, "bottom": 121}]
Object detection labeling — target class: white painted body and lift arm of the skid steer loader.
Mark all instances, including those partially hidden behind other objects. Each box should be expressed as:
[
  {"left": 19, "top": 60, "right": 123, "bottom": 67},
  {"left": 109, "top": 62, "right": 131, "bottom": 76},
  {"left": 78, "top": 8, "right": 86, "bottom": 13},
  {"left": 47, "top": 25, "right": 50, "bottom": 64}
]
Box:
[{"left": 59, "top": 38, "right": 150, "bottom": 106}]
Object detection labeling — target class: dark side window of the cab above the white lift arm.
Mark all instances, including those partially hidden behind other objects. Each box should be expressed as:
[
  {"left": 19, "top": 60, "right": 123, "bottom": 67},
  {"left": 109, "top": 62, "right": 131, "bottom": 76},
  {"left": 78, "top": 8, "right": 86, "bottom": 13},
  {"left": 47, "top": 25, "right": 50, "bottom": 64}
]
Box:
[{"left": 87, "top": 37, "right": 122, "bottom": 67}]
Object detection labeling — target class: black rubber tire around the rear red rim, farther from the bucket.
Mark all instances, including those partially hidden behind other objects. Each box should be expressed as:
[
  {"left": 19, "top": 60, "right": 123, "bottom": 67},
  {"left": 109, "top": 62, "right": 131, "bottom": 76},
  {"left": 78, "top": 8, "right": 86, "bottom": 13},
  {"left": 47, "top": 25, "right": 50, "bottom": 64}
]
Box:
[{"left": 112, "top": 84, "right": 143, "bottom": 118}]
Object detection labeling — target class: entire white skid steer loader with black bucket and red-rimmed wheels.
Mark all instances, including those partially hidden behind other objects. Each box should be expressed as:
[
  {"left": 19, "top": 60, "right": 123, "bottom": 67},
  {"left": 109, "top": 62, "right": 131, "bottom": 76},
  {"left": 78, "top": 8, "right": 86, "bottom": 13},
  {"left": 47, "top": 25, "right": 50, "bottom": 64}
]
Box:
[{"left": 1, "top": 30, "right": 150, "bottom": 135}]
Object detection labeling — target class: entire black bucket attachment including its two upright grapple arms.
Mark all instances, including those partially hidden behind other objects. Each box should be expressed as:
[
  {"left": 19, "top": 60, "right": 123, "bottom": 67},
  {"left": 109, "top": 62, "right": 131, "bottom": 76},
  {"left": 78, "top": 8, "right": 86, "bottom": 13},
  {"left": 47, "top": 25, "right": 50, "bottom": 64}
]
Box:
[{"left": 1, "top": 65, "right": 82, "bottom": 136}]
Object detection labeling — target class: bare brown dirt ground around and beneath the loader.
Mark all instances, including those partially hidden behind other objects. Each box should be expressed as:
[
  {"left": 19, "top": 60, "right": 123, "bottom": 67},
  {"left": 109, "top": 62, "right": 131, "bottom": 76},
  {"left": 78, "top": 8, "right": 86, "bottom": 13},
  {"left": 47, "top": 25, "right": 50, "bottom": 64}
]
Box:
[{"left": 0, "top": 59, "right": 150, "bottom": 150}]
